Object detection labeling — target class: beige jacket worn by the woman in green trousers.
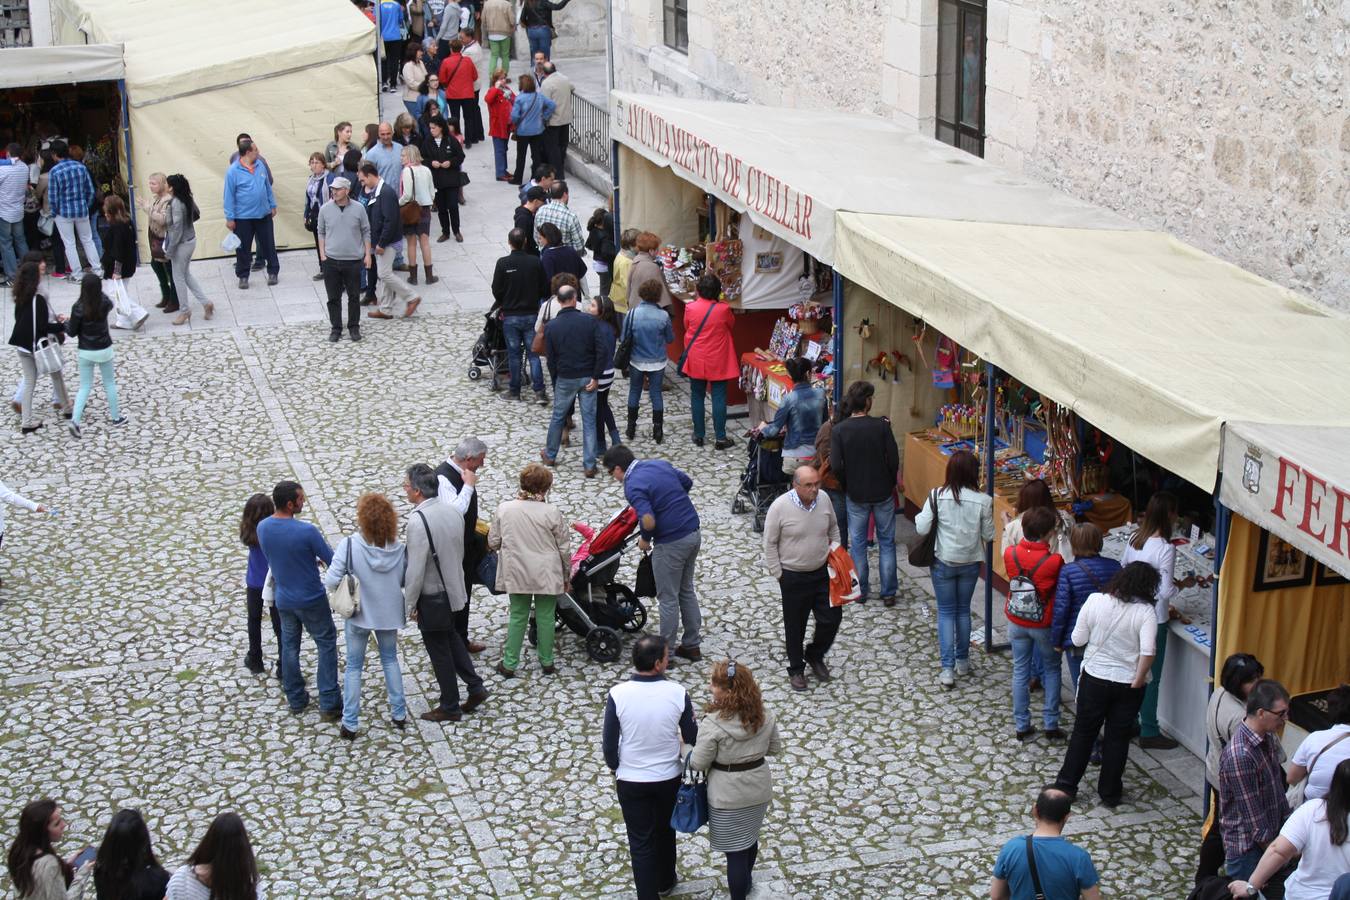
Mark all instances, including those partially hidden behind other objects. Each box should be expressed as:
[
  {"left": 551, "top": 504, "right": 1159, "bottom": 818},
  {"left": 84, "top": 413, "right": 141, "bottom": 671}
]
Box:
[{"left": 487, "top": 501, "right": 572, "bottom": 594}]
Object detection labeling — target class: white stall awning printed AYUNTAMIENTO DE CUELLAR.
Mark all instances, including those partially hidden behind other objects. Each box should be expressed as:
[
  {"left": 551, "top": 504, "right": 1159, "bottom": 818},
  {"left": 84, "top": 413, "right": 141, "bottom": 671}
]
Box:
[{"left": 610, "top": 92, "right": 1137, "bottom": 263}]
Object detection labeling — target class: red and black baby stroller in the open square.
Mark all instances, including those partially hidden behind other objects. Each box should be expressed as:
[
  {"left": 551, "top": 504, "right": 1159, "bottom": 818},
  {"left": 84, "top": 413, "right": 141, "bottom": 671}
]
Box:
[{"left": 529, "top": 506, "right": 647, "bottom": 663}]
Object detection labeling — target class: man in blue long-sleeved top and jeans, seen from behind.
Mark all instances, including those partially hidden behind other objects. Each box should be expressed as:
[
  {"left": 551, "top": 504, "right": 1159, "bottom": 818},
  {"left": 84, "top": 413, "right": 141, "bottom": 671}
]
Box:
[{"left": 258, "top": 482, "right": 342, "bottom": 722}]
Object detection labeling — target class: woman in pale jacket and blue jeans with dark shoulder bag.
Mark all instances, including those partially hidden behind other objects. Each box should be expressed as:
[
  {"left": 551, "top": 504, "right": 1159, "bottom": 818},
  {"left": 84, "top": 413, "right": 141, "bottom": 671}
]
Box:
[{"left": 912, "top": 450, "right": 994, "bottom": 688}]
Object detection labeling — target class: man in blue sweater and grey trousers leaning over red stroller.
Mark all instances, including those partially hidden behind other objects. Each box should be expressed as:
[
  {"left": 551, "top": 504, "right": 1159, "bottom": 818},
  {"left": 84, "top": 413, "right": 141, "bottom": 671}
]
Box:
[{"left": 605, "top": 444, "right": 703, "bottom": 665}]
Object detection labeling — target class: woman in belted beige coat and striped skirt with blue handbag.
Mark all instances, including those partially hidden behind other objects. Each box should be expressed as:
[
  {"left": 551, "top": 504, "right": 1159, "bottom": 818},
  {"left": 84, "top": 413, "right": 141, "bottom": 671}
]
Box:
[{"left": 689, "top": 660, "right": 783, "bottom": 900}]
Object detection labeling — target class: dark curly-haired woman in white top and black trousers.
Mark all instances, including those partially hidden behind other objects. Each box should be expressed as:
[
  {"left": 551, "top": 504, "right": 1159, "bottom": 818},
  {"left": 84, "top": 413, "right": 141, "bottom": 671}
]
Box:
[{"left": 1054, "top": 563, "right": 1158, "bottom": 807}]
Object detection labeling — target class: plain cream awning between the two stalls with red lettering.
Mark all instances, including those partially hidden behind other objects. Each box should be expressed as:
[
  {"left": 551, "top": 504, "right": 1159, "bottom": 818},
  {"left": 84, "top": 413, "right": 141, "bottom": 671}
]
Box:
[{"left": 834, "top": 212, "right": 1350, "bottom": 490}]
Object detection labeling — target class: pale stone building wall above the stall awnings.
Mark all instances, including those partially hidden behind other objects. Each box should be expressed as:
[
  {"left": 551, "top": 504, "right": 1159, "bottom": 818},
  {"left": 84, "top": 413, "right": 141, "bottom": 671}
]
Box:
[{"left": 614, "top": 0, "right": 1350, "bottom": 312}]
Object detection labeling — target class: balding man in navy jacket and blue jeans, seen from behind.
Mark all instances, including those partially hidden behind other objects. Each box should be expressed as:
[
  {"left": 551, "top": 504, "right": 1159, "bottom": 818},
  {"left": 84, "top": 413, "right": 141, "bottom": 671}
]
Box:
[{"left": 539, "top": 285, "right": 605, "bottom": 478}]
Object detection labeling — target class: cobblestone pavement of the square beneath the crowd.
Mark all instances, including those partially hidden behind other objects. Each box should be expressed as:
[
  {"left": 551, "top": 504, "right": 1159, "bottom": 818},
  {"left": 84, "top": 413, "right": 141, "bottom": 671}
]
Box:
[{"left": 0, "top": 95, "right": 1199, "bottom": 899}]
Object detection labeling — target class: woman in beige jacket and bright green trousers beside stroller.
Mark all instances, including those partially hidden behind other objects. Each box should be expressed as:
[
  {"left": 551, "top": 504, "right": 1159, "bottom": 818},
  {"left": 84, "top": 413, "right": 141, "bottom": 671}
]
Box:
[{"left": 487, "top": 463, "right": 571, "bottom": 679}]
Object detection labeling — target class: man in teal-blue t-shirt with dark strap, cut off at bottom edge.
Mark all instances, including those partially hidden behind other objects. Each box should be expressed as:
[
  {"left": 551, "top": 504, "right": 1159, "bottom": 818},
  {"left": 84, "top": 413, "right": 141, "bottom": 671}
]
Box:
[{"left": 990, "top": 785, "right": 1102, "bottom": 900}]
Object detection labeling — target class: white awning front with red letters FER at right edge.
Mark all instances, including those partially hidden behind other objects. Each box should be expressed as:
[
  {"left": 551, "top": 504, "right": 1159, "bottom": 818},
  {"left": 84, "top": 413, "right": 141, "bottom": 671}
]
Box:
[{"left": 1219, "top": 423, "right": 1350, "bottom": 578}]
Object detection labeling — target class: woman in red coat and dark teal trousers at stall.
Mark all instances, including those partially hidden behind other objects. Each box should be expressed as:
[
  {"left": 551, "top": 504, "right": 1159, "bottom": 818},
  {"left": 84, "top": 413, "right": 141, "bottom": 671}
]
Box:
[{"left": 684, "top": 273, "right": 741, "bottom": 449}]
